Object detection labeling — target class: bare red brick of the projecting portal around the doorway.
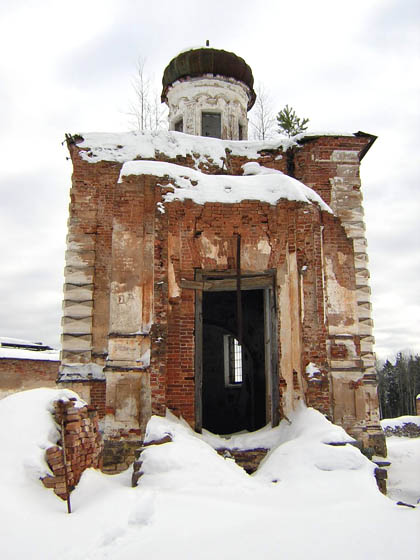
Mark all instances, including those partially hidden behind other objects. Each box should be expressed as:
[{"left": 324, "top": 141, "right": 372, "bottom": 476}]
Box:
[{"left": 162, "top": 201, "right": 330, "bottom": 424}]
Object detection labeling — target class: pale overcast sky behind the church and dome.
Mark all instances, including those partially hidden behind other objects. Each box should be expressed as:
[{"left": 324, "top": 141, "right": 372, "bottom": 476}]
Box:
[{"left": 0, "top": 0, "right": 420, "bottom": 359}]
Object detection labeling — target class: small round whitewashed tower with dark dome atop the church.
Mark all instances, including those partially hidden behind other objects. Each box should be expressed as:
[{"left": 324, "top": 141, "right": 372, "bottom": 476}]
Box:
[{"left": 161, "top": 47, "right": 256, "bottom": 140}]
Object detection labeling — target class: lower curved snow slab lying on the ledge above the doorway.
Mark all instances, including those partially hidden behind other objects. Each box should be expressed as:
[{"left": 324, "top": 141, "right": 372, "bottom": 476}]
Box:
[{"left": 118, "top": 161, "right": 332, "bottom": 213}]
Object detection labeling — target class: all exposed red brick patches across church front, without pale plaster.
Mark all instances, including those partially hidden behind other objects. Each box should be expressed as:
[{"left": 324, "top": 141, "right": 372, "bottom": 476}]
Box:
[{"left": 64, "top": 137, "right": 369, "bottom": 434}]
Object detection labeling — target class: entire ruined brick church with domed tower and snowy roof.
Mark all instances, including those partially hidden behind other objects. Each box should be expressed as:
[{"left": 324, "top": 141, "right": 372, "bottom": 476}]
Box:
[{"left": 59, "top": 48, "right": 383, "bottom": 463}]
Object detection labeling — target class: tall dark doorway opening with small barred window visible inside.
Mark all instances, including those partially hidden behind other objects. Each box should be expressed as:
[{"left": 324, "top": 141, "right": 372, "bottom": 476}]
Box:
[{"left": 202, "top": 289, "right": 267, "bottom": 434}]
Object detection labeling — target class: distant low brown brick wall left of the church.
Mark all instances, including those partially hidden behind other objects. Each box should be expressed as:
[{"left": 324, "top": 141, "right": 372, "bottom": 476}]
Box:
[{"left": 0, "top": 358, "right": 60, "bottom": 399}]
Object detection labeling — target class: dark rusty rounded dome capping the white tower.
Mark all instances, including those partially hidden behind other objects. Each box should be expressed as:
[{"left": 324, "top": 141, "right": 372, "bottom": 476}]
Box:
[{"left": 161, "top": 47, "right": 256, "bottom": 111}]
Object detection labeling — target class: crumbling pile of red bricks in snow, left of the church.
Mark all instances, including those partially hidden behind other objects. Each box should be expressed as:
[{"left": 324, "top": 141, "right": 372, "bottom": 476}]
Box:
[{"left": 42, "top": 399, "right": 103, "bottom": 500}]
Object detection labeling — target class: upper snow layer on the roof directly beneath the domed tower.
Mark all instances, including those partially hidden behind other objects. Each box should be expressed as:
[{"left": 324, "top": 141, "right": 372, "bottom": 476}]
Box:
[{"left": 77, "top": 130, "right": 296, "bottom": 167}]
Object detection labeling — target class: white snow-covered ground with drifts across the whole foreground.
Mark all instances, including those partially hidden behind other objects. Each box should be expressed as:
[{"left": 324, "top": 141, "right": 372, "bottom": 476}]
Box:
[{"left": 0, "top": 389, "right": 420, "bottom": 560}]
